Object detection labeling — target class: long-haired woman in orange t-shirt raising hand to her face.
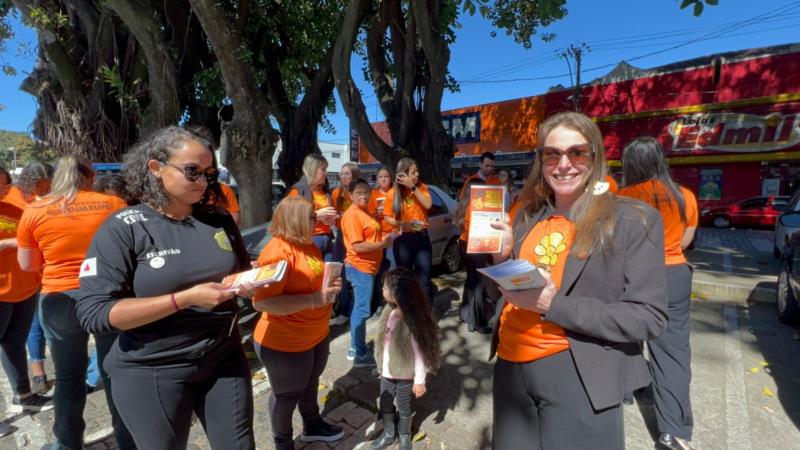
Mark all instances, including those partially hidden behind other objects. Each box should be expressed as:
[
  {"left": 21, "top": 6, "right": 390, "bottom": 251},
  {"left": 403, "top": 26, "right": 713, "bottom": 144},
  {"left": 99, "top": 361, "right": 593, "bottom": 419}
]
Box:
[{"left": 383, "top": 158, "right": 433, "bottom": 302}]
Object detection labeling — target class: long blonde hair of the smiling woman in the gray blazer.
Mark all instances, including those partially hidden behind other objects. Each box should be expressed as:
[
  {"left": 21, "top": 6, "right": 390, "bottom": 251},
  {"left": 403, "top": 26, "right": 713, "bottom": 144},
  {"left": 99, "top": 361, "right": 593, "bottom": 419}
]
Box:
[{"left": 520, "top": 112, "right": 616, "bottom": 258}]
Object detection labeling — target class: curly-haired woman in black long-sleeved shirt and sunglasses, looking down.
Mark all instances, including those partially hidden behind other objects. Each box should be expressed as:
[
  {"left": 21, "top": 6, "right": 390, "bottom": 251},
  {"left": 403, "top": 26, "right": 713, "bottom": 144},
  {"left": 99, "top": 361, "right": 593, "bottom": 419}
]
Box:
[{"left": 78, "top": 127, "right": 255, "bottom": 450}]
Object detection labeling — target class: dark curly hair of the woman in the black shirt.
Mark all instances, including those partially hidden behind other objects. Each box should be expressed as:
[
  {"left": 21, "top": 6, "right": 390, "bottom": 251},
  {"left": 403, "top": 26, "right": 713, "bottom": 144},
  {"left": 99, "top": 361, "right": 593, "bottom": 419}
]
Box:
[{"left": 123, "top": 126, "right": 226, "bottom": 211}]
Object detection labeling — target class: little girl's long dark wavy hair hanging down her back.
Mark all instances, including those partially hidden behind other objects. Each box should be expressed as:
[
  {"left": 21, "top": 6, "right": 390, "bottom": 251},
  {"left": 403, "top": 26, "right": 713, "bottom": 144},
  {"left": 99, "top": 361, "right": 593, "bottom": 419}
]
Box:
[{"left": 383, "top": 267, "right": 441, "bottom": 373}]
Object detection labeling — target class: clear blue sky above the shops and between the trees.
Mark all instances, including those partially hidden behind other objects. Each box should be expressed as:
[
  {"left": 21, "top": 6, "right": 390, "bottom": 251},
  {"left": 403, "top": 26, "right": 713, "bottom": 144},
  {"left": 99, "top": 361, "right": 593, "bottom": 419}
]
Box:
[{"left": 0, "top": 0, "right": 800, "bottom": 143}]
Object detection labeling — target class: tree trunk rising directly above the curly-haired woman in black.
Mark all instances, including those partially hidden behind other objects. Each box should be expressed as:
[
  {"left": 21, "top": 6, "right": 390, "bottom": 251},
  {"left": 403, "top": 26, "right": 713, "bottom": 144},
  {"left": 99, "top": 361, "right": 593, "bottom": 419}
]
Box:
[{"left": 106, "top": 0, "right": 180, "bottom": 135}]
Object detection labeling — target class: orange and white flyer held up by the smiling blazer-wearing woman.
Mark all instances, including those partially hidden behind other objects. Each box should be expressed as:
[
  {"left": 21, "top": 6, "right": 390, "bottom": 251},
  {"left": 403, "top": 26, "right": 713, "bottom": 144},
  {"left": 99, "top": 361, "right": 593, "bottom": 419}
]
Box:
[{"left": 467, "top": 185, "right": 506, "bottom": 253}]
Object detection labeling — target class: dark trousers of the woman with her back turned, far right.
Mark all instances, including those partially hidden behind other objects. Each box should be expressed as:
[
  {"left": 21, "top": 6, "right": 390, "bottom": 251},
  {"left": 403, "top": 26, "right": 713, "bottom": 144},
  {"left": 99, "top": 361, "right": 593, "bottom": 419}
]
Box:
[{"left": 648, "top": 264, "right": 694, "bottom": 440}]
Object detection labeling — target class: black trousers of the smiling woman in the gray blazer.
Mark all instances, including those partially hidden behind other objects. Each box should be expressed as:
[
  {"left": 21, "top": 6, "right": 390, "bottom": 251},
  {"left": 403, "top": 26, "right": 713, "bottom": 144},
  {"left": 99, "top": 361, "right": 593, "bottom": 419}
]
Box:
[{"left": 492, "top": 350, "right": 625, "bottom": 450}]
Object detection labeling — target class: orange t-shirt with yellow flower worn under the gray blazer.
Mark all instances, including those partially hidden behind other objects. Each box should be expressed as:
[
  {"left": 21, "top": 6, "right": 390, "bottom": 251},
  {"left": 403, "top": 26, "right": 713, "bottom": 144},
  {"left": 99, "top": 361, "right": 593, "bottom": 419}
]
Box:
[{"left": 497, "top": 216, "right": 575, "bottom": 362}]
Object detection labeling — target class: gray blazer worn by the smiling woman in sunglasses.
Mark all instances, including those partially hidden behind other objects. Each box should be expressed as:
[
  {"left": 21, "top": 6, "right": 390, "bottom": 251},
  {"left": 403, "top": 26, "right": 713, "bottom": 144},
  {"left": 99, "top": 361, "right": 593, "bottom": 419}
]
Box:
[{"left": 490, "top": 198, "right": 667, "bottom": 410}]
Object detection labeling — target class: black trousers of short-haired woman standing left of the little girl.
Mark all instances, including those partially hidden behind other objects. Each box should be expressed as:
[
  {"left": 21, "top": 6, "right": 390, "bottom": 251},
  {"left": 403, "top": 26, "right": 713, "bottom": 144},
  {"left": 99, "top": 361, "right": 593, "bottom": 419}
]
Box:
[{"left": 256, "top": 337, "right": 330, "bottom": 440}]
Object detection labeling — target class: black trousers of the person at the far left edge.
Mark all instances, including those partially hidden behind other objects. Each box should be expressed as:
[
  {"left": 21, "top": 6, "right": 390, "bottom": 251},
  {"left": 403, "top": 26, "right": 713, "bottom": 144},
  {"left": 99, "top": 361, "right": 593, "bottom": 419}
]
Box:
[{"left": 0, "top": 292, "right": 39, "bottom": 394}]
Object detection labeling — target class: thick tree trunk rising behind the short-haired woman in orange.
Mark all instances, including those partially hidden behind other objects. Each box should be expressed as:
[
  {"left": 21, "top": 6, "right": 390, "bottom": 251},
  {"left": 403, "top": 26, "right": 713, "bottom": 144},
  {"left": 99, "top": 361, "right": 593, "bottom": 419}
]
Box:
[{"left": 190, "top": 0, "right": 278, "bottom": 227}]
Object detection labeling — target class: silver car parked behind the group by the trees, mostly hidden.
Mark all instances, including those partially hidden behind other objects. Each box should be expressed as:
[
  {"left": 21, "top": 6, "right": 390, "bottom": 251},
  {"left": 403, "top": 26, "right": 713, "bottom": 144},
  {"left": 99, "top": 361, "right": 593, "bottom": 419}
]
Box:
[{"left": 242, "top": 185, "right": 462, "bottom": 273}]
